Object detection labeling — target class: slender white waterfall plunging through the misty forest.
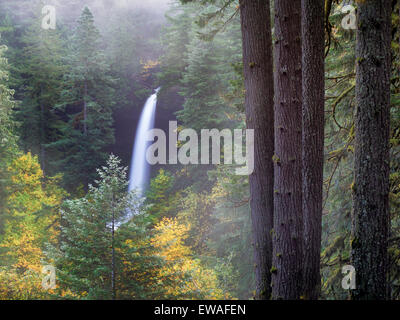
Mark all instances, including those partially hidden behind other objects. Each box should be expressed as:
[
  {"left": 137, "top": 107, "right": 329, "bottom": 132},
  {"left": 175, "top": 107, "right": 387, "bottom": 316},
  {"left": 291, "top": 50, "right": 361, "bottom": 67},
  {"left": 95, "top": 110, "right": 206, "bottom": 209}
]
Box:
[{"left": 129, "top": 88, "right": 160, "bottom": 196}]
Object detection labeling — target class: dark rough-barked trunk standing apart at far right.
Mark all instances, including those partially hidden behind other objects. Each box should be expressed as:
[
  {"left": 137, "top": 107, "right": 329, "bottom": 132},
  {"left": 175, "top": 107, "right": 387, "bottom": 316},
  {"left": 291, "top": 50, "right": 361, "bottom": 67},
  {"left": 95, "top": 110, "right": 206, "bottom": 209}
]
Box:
[{"left": 351, "top": 0, "right": 391, "bottom": 300}]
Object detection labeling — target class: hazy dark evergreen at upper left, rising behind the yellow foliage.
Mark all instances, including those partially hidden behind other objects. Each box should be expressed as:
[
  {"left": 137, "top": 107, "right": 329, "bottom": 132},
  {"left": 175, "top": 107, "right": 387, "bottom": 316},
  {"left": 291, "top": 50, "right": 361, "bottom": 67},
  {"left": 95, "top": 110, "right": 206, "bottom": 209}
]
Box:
[{"left": 16, "top": 10, "right": 66, "bottom": 173}]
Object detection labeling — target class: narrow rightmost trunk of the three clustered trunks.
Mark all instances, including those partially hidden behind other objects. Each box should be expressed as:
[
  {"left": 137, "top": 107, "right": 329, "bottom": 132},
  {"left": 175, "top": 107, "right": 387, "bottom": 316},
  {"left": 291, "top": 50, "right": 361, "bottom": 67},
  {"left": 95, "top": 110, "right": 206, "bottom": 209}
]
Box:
[{"left": 302, "top": 0, "right": 325, "bottom": 300}]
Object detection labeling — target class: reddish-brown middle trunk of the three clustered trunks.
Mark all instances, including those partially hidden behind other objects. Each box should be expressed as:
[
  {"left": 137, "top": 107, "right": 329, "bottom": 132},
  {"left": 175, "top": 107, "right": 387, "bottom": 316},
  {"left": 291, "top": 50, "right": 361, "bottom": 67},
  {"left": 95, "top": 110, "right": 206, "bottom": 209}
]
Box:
[{"left": 272, "top": 0, "right": 303, "bottom": 299}]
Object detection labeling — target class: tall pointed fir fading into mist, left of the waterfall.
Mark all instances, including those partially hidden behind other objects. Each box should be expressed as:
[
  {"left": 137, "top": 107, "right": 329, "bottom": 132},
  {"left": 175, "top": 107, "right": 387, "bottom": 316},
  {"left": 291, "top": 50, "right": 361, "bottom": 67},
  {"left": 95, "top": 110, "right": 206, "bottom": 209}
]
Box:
[{"left": 49, "top": 7, "right": 114, "bottom": 188}]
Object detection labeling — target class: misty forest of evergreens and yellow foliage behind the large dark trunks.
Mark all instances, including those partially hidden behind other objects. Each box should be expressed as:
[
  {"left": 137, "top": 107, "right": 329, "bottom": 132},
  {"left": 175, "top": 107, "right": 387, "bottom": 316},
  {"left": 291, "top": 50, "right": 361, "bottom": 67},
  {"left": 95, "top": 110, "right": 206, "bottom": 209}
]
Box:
[{"left": 0, "top": 0, "right": 400, "bottom": 300}]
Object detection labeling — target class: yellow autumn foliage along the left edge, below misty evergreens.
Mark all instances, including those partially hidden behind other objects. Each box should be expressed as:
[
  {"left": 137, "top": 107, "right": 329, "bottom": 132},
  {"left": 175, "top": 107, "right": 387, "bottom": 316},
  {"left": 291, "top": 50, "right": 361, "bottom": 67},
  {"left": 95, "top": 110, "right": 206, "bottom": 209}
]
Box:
[{"left": 0, "top": 153, "right": 65, "bottom": 299}]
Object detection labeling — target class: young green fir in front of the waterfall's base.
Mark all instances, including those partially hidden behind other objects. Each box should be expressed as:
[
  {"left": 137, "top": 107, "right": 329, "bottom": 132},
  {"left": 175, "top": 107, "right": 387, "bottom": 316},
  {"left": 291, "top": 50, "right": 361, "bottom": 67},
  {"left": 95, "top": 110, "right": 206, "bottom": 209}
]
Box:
[{"left": 53, "top": 155, "right": 162, "bottom": 299}]
